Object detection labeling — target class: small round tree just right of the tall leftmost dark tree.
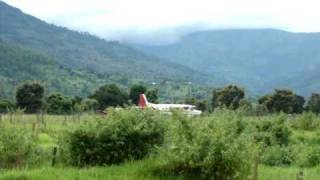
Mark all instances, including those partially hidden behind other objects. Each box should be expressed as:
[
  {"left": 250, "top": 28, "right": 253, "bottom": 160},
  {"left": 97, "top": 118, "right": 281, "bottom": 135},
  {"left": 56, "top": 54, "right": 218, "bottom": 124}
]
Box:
[{"left": 46, "top": 93, "right": 73, "bottom": 114}]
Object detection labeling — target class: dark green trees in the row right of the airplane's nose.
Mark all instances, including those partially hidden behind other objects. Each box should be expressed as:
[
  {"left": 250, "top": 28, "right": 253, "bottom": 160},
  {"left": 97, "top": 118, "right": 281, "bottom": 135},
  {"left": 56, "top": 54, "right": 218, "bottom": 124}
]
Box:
[{"left": 212, "top": 85, "right": 320, "bottom": 114}]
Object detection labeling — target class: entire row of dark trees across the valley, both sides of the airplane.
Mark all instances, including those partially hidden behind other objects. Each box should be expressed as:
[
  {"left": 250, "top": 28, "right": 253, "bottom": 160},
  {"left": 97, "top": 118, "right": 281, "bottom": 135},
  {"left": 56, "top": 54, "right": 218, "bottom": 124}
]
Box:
[{"left": 0, "top": 82, "right": 320, "bottom": 114}]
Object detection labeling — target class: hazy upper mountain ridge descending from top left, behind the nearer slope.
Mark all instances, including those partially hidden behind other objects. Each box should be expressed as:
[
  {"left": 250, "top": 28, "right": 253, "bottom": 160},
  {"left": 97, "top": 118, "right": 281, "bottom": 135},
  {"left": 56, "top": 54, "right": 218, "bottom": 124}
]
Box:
[{"left": 0, "top": 1, "right": 216, "bottom": 83}]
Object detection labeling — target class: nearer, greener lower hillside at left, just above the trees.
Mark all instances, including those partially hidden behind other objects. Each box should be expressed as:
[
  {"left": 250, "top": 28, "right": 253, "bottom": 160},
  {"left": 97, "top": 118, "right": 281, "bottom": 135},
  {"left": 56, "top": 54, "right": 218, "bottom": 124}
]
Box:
[{"left": 0, "top": 42, "right": 106, "bottom": 98}]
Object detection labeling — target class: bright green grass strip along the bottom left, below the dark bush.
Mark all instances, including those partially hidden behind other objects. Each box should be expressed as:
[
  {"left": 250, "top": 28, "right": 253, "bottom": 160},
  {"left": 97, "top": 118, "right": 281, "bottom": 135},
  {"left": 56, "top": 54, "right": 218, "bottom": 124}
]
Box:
[{"left": 0, "top": 160, "right": 185, "bottom": 180}]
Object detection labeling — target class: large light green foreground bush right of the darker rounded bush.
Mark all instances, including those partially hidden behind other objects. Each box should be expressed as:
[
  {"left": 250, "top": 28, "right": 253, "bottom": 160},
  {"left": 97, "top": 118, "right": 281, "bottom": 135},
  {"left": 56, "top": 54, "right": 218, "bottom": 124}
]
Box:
[{"left": 158, "top": 111, "right": 253, "bottom": 180}]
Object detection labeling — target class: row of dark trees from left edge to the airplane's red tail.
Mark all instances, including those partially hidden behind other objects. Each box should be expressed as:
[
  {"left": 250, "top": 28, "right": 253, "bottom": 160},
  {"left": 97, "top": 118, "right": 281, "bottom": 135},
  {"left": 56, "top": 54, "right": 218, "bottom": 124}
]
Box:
[{"left": 0, "top": 82, "right": 158, "bottom": 114}]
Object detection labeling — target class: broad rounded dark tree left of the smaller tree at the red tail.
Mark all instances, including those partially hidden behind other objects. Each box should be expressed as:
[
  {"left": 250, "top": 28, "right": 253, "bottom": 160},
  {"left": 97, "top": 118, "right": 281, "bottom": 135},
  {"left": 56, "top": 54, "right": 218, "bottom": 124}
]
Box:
[{"left": 89, "top": 84, "right": 128, "bottom": 110}]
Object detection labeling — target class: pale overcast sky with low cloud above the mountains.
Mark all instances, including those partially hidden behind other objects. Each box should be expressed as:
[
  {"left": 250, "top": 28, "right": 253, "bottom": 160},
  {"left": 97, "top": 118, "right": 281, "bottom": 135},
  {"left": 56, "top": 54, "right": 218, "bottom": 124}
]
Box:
[{"left": 4, "top": 0, "right": 320, "bottom": 41}]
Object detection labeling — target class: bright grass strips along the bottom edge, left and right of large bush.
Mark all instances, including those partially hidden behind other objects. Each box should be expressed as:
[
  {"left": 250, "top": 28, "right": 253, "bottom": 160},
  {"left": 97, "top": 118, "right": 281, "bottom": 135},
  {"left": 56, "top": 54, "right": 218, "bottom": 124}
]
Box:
[{"left": 0, "top": 160, "right": 320, "bottom": 180}]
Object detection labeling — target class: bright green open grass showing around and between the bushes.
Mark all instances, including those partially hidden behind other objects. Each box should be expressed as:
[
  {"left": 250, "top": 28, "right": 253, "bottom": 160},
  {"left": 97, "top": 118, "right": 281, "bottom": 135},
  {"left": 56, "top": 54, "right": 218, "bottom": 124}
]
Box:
[{"left": 0, "top": 114, "right": 320, "bottom": 180}]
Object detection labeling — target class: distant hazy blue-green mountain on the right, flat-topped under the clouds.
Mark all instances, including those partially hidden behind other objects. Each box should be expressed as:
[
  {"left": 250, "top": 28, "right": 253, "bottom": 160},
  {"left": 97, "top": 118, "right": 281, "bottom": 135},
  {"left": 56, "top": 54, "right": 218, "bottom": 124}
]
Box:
[{"left": 135, "top": 29, "right": 320, "bottom": 95}]
